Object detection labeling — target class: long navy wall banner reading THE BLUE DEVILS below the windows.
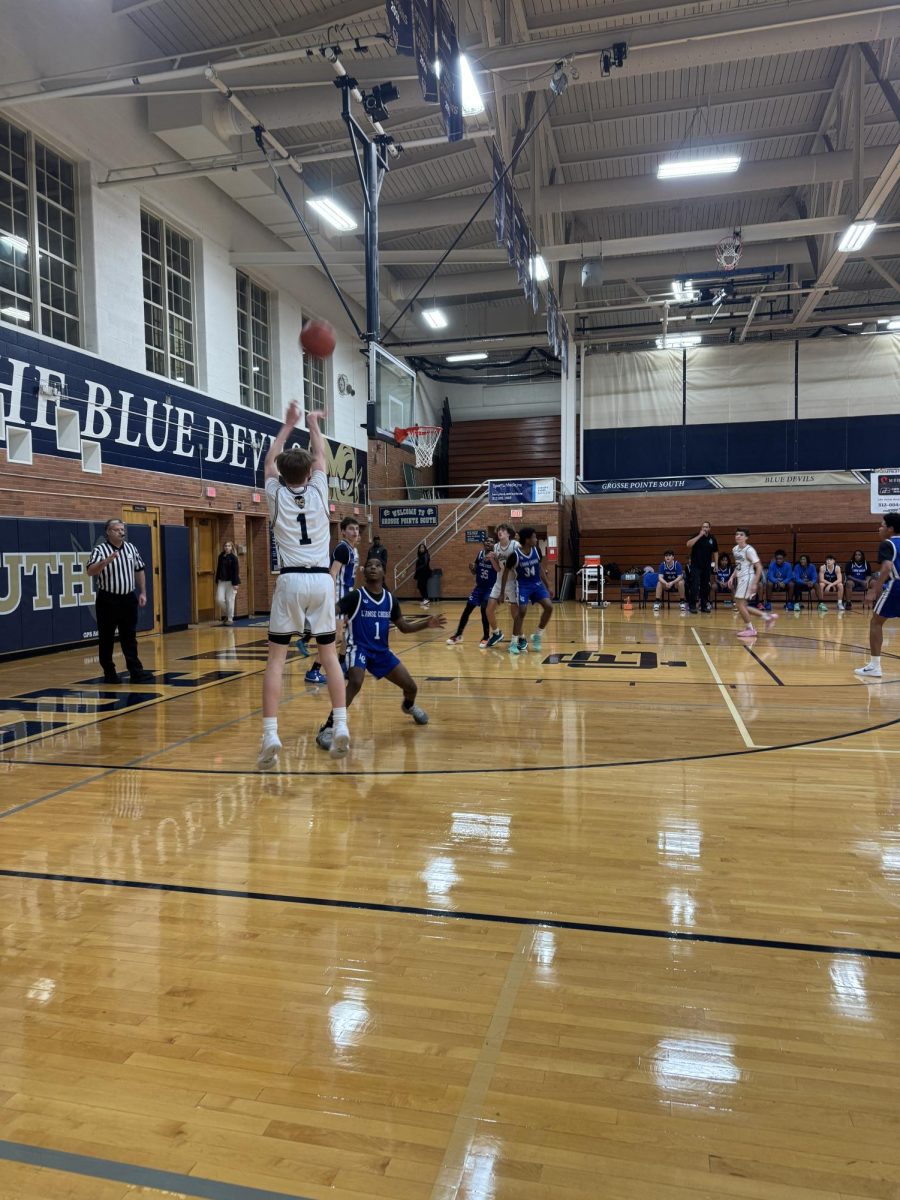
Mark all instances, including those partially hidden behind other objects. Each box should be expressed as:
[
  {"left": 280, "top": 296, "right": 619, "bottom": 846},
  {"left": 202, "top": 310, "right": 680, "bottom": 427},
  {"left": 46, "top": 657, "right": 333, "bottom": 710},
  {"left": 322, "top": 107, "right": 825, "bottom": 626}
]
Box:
[{"left": 0, "top": 329, "right": 366, "bottom": 503}]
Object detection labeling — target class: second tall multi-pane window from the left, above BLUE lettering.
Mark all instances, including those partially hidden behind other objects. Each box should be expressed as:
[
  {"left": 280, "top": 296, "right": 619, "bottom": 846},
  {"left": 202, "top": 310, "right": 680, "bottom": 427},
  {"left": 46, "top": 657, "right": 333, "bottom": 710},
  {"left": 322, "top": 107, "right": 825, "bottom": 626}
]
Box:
[{"left": 140, "top": 209, "right": 196, "bottom": 384}]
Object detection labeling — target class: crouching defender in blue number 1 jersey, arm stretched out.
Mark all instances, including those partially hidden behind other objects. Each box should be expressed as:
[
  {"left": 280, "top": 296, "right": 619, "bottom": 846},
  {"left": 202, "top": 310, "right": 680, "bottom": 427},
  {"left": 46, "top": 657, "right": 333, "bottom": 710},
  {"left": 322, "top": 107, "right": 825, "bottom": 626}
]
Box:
[{"left": 316, "top": 558, "right": 446, "bottom": 750}]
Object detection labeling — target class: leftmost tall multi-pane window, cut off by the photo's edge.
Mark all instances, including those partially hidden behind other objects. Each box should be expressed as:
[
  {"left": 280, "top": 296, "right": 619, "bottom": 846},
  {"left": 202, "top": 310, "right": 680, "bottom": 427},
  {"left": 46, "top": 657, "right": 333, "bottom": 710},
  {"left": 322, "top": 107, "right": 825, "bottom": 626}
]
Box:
[{"left": 0, "top": 120, "right": 80, "bottom": 346}]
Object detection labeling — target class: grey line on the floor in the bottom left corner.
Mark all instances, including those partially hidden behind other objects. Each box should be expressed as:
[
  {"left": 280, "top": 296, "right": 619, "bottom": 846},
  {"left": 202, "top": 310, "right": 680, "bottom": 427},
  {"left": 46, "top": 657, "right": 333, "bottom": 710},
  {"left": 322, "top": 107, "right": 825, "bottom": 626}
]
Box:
[{"left": 0, "top": 1140, "right": 308, "bottom": 1200}]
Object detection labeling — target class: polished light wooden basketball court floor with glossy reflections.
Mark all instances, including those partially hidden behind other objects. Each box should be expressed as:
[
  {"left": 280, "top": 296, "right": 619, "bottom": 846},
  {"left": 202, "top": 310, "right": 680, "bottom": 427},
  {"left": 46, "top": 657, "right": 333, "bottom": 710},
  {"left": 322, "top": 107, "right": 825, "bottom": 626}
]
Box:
[{"left": 0, "top": 604, "right": 900, "bottom": 1200}]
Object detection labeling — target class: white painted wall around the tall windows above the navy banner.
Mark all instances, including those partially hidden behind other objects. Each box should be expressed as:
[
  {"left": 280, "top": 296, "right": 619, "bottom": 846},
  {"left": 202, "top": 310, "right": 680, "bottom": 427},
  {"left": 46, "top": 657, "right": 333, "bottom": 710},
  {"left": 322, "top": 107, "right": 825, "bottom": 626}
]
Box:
[{"left": 0, "top": 0, "right": 388, "bottom": 449}]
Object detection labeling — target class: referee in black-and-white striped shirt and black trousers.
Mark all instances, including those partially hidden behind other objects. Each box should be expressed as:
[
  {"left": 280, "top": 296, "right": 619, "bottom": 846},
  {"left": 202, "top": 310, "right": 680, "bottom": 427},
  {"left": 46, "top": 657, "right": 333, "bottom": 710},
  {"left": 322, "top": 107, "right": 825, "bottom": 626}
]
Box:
[{"left": 88, "top": 517, "right": 154, "bottom": 683}]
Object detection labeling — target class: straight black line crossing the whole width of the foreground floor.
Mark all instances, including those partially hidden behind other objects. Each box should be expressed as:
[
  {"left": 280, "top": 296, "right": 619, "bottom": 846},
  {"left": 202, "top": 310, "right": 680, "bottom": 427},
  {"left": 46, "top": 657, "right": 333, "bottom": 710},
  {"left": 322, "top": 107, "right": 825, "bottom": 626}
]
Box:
[{"left": 0, "top": 868, "right": 900, "bottom": 960}]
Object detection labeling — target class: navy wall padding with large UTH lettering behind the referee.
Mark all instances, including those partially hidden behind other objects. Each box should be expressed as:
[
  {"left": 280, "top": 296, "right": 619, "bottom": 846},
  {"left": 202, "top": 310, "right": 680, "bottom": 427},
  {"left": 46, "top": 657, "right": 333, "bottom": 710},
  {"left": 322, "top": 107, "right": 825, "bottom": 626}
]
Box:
[{"left": 0, "top": 517, "right": 155, "bottom": 654}]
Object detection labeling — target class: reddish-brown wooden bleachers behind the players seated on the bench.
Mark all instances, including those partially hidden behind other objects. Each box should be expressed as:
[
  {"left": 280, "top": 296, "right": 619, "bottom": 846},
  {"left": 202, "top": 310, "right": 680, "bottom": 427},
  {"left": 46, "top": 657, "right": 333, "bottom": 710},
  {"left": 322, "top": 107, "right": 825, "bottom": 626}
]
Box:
[{"left": 581, "top": 517, "right": 878, "bottom": 600}]
